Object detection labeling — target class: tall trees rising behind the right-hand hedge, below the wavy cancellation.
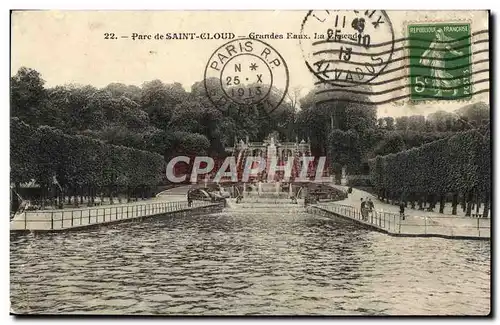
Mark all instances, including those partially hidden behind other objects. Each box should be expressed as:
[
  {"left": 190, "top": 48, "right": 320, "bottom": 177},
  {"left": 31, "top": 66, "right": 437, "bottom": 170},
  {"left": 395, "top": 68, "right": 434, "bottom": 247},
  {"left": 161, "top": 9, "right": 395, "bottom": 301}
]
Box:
[{"left": 295, "top": 86, "right": 489, "bottom": 174}]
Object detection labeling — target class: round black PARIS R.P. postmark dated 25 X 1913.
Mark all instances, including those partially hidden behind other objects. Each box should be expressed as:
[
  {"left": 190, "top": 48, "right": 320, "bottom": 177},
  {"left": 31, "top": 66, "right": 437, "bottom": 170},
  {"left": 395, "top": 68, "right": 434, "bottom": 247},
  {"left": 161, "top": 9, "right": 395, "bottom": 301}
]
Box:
[{"left": 204, "top": 38, "right": 289, "bottom": 114}]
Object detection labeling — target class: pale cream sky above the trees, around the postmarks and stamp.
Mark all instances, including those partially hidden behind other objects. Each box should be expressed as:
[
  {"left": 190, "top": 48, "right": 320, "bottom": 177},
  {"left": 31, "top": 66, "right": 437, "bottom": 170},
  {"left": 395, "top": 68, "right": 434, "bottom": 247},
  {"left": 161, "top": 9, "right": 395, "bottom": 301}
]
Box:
[{"left": 11, "top": 10, "right": 489, "bottom": 117}]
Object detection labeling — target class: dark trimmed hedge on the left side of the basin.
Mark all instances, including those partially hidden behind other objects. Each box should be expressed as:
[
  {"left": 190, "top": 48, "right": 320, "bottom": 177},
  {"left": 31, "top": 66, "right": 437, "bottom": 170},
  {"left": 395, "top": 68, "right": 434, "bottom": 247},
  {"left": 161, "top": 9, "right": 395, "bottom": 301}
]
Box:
[{"left": 10, "top": 118, "right": 165, "bottom": 197}]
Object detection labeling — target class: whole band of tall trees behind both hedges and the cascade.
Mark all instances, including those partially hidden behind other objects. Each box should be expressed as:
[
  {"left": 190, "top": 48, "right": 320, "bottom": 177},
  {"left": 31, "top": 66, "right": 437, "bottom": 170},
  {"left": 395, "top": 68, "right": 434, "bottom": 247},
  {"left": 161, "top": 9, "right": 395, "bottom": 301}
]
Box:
[{"left": 11, "top": 68, "right": 489, "bottom": 168}]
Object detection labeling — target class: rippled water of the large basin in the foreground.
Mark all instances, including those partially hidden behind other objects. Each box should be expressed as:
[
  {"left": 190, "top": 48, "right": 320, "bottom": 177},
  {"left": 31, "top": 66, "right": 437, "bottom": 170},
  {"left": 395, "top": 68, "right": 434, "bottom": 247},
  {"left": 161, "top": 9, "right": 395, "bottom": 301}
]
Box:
[{"left": 11, "top": 212, "right": 490, "bottom": 315}]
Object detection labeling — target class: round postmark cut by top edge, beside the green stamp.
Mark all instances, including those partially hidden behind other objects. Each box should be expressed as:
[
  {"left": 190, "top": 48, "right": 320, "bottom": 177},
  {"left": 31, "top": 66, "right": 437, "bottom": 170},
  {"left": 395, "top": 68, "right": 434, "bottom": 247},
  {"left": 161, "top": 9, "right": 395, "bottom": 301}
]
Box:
[{"left": 300, "top": 10, "right": 394, "bottom": 87}]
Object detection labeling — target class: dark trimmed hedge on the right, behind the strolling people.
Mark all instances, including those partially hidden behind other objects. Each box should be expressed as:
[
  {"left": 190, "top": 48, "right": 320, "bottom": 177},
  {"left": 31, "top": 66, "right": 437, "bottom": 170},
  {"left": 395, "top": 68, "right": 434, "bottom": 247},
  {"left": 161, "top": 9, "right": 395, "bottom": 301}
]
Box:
[{"left": 369, "top": 130, "right": 491, "bottom": 214}]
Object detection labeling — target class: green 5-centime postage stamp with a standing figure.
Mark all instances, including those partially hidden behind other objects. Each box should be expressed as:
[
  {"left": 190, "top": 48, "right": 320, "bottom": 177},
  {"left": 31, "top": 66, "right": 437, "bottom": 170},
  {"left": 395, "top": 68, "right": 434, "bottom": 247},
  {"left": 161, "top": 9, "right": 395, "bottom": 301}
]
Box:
[{"left": 408, "top": 23, "right": 472, "bottom": 100}]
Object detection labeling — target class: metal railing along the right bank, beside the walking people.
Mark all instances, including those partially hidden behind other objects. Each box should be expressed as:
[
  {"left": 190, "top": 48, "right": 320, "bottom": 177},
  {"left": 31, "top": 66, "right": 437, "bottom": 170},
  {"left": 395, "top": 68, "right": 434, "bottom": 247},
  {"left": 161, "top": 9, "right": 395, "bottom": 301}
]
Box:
[{"left": 315, "top": 203, "right": 491, "bottom": 238}]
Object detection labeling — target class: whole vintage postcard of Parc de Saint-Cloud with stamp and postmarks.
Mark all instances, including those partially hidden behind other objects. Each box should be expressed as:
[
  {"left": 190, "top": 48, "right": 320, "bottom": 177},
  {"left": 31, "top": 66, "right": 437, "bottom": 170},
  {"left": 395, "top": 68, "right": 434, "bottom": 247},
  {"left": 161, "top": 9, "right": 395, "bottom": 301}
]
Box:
[{"left": 10, "top": 9, "right": 492, "bottom": 316}]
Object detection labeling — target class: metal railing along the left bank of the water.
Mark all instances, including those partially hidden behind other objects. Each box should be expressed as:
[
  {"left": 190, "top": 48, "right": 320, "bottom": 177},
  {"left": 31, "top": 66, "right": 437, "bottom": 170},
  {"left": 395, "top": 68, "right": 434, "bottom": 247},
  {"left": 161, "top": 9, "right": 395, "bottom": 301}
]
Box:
[{"left": 11, "top": 201, "right": 217, "bottom": 230}]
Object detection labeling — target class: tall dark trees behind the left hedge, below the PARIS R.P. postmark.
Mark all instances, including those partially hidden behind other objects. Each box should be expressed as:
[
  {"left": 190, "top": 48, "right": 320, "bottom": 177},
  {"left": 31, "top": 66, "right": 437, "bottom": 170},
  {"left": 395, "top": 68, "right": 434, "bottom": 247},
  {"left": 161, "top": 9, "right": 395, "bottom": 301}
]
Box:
[{"left": 11, "top": 67, "right": 294, "bottom": 156}]
